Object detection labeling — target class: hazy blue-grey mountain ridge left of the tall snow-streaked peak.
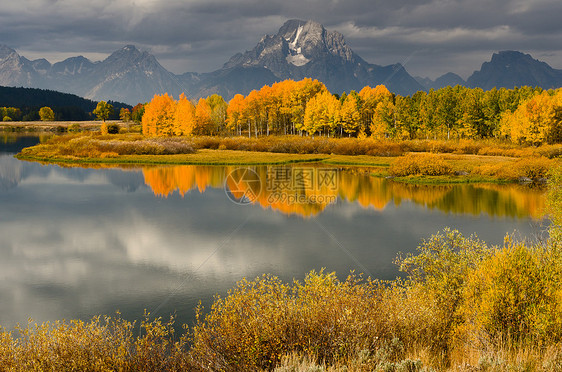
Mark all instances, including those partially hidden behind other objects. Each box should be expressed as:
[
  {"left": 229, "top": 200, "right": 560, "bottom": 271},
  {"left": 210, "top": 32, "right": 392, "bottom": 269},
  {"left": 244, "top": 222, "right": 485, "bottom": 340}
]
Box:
[{"left": 0, "top": 45, "right": 189, "bottom": 103}]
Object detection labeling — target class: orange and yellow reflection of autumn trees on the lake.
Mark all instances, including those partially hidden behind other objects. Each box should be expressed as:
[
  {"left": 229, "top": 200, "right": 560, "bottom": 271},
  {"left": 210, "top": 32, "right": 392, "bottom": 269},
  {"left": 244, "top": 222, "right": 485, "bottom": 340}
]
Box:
[{"left": 139, "top": 165, "right": 545, "bottom": 218}]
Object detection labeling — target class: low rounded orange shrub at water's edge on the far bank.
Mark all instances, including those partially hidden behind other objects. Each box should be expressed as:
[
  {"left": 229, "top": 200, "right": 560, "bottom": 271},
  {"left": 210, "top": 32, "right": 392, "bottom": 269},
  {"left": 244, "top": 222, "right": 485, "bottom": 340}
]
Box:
[{"left": 389, "top": 153, "right": 452, "bottom": 177}]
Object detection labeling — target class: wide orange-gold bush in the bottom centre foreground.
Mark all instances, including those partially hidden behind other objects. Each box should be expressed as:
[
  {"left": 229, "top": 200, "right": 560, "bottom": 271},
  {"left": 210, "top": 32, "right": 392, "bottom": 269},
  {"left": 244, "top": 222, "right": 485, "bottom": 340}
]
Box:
[{"left": 191, "top": 272, "right": 385, "bottom": 370}]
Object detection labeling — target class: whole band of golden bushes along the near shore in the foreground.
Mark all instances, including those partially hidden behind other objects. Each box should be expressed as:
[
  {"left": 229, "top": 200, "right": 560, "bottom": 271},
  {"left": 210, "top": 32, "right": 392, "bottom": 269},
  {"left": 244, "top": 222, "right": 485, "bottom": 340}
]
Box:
[{"left": 0, "top": 224, "right": 562, "bottom": 372}]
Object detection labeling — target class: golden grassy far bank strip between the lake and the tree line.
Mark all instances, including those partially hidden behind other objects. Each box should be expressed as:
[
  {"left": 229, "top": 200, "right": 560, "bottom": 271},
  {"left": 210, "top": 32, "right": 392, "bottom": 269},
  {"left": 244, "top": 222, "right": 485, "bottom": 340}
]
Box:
[{"left": 16, "top": 132, "right": 562, "bottom": 184}]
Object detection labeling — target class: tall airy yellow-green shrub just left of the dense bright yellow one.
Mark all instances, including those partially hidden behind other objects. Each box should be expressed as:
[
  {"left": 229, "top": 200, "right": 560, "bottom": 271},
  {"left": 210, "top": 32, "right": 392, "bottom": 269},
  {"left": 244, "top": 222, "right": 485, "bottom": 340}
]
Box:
[{"left": 396, "top": 229, "right": 491, "bottom": 353}]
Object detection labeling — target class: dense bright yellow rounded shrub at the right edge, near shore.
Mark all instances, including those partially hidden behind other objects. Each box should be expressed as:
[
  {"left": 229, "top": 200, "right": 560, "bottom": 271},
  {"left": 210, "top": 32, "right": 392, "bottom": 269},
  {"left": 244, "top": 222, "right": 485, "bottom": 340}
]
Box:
[{"left": 463, "top": 242, "right": 562, "bottom": 345}]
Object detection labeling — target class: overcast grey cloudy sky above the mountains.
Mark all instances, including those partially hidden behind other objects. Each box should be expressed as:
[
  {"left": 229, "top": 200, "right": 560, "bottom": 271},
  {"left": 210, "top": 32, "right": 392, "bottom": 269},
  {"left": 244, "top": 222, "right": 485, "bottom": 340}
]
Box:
[{"left": 0, "top": 0, "right": 562, "bottom": 78}]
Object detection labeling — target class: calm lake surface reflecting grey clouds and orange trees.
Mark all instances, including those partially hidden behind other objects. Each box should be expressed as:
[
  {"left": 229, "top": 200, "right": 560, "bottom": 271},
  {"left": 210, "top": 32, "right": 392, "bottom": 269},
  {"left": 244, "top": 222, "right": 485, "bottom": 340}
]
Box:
[{"left": 0, "top": 134, "right": 544, "bottom": 328}]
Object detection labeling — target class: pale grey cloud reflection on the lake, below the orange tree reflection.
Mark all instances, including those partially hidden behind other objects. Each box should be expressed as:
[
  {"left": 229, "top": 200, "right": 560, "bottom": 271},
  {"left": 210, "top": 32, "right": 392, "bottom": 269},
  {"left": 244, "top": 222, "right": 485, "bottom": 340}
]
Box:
[{"left": 0, "top": 148, "right": 544, "bottom": 327}]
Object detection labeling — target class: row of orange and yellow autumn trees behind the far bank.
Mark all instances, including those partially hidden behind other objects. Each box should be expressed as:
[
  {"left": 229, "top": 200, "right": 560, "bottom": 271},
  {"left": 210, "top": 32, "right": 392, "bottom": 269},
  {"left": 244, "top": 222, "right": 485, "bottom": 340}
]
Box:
[{"left": 133, "top": 79, "right": 562, "bottom": 145}]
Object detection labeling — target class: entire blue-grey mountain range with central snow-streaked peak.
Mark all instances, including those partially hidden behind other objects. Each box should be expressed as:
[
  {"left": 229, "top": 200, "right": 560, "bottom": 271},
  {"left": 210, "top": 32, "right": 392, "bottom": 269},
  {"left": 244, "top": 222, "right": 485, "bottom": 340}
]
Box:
[{"left": 0, "top": 20, "right": 562, "bottom": 105}]
